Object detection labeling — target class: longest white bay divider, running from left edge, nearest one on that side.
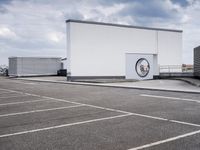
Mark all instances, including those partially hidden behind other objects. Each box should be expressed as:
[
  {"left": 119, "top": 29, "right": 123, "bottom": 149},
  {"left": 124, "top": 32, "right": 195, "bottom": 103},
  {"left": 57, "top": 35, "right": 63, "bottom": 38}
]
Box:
[{"left": 0, "top": 114, "right": 132, "bottom": 138}]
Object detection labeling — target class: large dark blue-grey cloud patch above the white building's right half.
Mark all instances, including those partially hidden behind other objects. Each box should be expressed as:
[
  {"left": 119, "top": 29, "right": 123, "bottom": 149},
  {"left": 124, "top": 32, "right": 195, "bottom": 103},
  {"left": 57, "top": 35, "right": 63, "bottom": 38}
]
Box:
[{"left": 111, "top": 0, "right": 182, "bottom": 26}]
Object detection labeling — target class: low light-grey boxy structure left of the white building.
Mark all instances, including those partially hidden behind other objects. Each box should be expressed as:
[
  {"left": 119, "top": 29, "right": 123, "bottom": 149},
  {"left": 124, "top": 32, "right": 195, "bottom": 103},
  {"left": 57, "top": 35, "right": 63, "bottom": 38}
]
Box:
[{"left": 9, "top": 57, "right": 61, "bottom": 76}]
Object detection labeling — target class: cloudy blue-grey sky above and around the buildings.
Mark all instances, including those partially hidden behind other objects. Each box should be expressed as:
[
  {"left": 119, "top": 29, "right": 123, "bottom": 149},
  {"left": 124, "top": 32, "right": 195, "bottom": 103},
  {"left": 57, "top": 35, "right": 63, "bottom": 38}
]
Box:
[{"left": 0, "top": 0, "right": 200, "bottom": 64}]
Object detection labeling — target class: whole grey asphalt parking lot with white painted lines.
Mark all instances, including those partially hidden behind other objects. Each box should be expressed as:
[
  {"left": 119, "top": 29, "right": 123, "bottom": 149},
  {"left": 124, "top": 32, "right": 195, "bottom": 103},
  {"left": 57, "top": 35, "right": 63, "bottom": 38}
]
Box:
[{"left": 0, "top": 77, "right": 200, "bottom": 150}]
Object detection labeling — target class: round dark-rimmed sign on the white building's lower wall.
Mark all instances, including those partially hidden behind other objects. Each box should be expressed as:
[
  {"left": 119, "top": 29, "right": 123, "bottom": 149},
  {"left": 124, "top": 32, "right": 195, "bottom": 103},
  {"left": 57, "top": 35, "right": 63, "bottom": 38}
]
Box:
[{"left": 135, "top": 58, "right": 150, "bottom": 77}]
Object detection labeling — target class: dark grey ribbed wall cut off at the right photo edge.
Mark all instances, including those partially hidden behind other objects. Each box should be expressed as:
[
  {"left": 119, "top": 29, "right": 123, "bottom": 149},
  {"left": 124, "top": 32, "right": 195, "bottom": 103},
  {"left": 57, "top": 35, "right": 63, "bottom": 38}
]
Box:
[{"left": 194, "top": 46, "right": 200, "bottom": 77}]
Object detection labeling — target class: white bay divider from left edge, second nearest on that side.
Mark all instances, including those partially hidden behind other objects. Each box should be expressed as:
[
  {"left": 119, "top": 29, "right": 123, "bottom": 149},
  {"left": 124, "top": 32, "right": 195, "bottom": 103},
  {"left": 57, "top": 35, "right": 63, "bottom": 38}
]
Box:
[{"left": 0, "top": 105, "right": 85, "bottom": 117}]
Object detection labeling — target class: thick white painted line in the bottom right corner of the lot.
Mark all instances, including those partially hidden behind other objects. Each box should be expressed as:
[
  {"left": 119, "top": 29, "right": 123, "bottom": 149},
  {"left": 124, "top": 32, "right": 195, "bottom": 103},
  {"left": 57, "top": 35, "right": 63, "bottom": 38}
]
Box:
[{"left": 128, "top": 130, "right": 200, "bottom": 150}]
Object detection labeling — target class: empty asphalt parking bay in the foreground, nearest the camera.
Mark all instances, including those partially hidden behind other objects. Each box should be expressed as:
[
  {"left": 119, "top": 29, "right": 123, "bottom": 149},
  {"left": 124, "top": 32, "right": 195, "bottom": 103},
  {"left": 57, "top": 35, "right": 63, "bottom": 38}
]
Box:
[{"left": 0, "top": 116, "right": 197, "bottom": 150}]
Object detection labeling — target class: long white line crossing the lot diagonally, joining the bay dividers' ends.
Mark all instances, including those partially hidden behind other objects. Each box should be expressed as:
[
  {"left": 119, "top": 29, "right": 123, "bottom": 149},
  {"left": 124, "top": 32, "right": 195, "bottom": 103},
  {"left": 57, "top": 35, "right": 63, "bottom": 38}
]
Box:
[{"left": 0, "top": 89, "right": 200, "bottom": 127}]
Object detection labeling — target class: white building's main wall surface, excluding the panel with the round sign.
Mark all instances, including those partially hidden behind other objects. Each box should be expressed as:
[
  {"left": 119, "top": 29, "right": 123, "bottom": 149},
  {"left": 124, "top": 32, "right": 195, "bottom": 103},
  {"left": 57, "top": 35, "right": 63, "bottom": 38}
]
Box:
[{"left": 67, "top": 22, "right": 181, "bottom": 76}]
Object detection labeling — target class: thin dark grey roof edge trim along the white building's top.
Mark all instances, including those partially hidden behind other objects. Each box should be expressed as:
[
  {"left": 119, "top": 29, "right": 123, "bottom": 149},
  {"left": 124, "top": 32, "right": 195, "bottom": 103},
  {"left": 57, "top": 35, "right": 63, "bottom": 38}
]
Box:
[{"left": 66, "top": 19, "right": 183, "bottom": 32}]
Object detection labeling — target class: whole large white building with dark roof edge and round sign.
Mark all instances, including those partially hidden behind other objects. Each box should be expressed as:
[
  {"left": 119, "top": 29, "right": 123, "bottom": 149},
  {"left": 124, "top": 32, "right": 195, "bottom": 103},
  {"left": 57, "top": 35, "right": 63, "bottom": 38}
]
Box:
[{"left": 66, "top": 20, "right": 182, "bottom": 79}]
